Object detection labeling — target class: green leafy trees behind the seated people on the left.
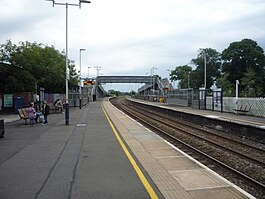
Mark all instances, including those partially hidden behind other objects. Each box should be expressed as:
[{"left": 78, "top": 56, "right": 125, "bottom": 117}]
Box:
[{"left": 0, "top": 40, "right": 78, "bottom": 93}]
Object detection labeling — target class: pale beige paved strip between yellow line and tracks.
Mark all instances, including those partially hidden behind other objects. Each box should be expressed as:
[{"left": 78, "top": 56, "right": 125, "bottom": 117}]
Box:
[{"left": 104, "top": 98, "right": 254, "bottom": 199}]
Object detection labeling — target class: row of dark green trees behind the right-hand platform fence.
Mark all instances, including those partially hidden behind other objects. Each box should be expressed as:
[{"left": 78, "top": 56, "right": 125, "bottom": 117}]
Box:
[{"left": 170, "top": 39, "right": 265, "bottom": 97}]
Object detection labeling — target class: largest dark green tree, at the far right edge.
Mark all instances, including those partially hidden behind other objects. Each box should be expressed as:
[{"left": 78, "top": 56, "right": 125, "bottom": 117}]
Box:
[{"left": 221, "top": 39, "right": 265, "bottom": 96}]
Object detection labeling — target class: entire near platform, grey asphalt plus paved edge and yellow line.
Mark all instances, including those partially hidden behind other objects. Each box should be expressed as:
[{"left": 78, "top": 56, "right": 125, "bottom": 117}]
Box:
[{"left": 0, "top": 99, "right": 254, "bottom": 199}]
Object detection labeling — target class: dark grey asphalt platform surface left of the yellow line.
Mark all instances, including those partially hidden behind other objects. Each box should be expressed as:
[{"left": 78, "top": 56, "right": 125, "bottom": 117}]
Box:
[{"left": 0, "top": 102, "right": 163, "bottom": 199}]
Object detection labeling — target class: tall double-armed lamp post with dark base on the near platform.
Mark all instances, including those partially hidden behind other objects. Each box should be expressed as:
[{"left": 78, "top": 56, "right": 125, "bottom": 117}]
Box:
[{"left": 46, "top": 0, "right": 91, "bottom": 125}]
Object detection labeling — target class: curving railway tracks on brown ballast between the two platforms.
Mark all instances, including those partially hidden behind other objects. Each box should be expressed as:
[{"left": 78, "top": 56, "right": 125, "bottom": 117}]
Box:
[{"left": 111, "top": 98, "right": 265, "bottom": 198}]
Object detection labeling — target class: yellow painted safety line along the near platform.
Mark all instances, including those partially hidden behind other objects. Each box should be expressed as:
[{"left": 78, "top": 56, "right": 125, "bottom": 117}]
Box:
[{"left": 102, "top": 104, "right": 158, "bottom": 199}]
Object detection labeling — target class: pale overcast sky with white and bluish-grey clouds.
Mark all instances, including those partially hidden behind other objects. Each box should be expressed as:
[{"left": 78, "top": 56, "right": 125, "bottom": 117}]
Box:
[{"left": 0, "top": 0, "right": 265, "bottom": 91}]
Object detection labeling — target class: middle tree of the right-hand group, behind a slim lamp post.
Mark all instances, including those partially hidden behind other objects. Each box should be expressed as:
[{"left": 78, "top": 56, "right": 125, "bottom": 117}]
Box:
[{"left": 191, "top": 48, "right": 221, "bottom": 88}]
